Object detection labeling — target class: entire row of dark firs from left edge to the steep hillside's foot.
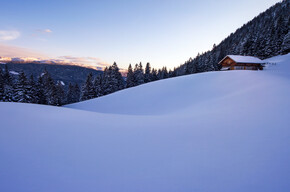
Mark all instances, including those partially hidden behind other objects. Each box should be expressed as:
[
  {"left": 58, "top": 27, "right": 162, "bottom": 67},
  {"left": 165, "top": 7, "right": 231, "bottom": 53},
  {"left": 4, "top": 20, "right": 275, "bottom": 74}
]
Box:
[{"left": 0, "top": 63, "right": 175, "bottom": 106}]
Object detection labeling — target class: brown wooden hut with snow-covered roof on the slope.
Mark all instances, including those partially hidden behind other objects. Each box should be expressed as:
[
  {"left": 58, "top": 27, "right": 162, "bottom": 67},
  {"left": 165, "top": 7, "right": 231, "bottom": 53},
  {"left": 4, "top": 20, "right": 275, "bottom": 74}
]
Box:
[{"left": 219, "top": 55, "right": 264, "bottom": 70}]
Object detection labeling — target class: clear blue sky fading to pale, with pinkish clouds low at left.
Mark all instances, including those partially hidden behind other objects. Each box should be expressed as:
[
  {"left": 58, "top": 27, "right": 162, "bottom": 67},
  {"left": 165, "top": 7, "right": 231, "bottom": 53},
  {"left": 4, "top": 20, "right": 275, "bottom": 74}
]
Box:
[{"left": 0, "top": 0, "right": 279, "bottom": 69}]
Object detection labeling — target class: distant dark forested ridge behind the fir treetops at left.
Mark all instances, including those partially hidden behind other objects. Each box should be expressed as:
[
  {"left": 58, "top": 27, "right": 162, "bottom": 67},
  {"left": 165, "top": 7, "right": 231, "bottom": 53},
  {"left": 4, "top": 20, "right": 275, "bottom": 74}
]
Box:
[{"left": 0, "top": 61, "right": 103, "bottom": 86}]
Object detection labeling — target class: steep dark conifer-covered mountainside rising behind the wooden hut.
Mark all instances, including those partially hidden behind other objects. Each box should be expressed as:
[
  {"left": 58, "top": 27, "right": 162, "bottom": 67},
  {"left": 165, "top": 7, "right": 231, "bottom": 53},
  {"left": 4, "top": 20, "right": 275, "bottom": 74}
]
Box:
[{"left": 175, "top": 0, "right": 290, "bottom": 75}]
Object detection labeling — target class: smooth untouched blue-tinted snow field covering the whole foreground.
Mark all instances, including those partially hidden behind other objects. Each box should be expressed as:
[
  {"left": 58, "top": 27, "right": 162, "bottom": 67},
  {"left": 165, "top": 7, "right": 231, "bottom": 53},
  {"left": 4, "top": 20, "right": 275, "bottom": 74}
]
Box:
[{"left": 0, "top": 54, "right": 290, "bottom": 192}]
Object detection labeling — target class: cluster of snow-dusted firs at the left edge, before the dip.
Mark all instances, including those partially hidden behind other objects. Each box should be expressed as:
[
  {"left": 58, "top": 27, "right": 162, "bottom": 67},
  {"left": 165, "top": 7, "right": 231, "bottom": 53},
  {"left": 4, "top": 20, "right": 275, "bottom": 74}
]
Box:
[{"left": 0, "top": 65, "right": 74, "bottom": 106}]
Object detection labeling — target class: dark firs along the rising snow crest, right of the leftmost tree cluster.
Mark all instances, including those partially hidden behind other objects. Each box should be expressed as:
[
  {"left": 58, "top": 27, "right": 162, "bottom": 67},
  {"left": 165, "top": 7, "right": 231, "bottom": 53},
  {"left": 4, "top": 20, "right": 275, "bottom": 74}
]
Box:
[{"left": 78, "top": 62, "right": 176, "bottom": 102}]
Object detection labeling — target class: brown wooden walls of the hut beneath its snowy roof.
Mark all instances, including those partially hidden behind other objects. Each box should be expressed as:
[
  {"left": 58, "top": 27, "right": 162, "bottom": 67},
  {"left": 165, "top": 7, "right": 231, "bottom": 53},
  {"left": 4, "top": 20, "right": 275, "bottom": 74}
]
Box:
[{"left": 220, "top": 57, "right": 263, "bottom": 70}]
